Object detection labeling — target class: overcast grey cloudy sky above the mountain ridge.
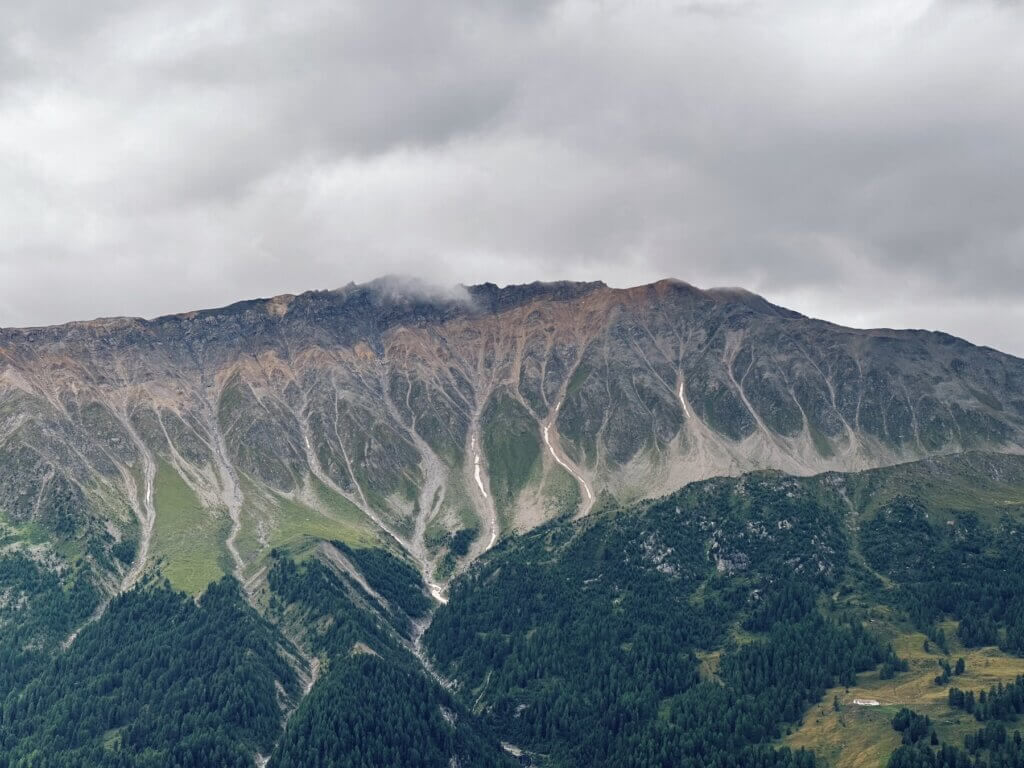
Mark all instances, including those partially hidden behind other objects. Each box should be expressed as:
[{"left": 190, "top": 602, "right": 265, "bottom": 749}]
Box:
[{"left": 0, "top": 0, "right": 1024, "bottom": 355}]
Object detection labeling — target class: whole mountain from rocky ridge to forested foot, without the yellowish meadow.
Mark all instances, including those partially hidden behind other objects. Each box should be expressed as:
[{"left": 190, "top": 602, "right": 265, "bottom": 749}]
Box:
[{"left": 0, "top": 278, "right": 1024, "bottom": 768}]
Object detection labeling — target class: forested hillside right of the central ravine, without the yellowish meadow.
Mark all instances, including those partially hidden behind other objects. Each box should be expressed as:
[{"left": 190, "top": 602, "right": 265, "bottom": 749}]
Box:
[{"left": 425, "top": 455, "right": 1024, "bottom": 766}]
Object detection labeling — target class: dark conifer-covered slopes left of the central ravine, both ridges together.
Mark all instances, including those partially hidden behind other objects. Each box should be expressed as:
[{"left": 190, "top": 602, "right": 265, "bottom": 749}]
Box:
[{"left": 0, "top": 552, "right": 508, "bottom": 768}]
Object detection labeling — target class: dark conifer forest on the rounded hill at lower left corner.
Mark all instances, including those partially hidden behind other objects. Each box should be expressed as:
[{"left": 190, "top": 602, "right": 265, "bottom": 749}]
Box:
[{"left": 0, "top": 579, "right": 297, "bottom": 768}]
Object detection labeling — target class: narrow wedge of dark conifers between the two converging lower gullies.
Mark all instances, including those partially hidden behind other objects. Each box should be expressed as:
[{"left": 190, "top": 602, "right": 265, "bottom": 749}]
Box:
[{"left": 269, "top": 558, "right": 507, "bottom": 768}]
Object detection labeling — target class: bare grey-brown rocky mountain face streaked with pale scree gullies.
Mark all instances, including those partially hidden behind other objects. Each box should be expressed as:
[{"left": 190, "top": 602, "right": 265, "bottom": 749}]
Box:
[{"left": 0, "top": 280, "right": 1024, "bottom": 594}]
